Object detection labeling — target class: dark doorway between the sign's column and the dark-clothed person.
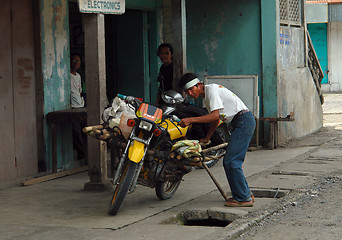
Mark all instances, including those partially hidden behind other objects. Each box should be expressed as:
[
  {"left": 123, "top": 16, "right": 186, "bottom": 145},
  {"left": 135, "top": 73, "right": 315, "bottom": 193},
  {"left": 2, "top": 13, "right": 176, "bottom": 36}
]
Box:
[{"left": 105, "top": 10, "right": 157, "bottom": 102}]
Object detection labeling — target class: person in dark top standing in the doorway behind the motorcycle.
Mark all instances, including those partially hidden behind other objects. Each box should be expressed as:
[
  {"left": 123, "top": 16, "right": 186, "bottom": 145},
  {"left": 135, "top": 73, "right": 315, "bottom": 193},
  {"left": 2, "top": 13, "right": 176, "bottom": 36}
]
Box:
[{"left": 156, "top": 43, "right": 173, "bottom": 106}]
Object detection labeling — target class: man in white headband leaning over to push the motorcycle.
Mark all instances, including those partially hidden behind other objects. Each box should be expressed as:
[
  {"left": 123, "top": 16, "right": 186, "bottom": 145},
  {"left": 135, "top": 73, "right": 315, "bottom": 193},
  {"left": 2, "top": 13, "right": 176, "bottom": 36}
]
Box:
[{"left": 179, "top": 73, "right": 255, "bottom": 207}]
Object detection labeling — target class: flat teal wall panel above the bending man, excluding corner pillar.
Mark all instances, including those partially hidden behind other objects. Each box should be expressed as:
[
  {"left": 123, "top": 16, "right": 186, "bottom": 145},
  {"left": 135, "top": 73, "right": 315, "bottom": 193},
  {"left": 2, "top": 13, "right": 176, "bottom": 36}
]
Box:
[{"left": 186, "top": 0, "right": 261, "bottom": 77}]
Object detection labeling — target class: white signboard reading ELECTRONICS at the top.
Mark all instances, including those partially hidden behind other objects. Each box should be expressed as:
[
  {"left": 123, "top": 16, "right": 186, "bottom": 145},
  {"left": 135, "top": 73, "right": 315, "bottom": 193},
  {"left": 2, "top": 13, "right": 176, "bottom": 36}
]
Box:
[{"left": 78, "top": 0, "right": 125, "bottom": 14}]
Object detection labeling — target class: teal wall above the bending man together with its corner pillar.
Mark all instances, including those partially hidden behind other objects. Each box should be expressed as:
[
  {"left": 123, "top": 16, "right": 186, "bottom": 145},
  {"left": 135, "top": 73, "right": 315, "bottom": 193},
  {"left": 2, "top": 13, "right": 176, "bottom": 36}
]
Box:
[{"left": 186, "top": 0, "right": 279, "bottom": 142}]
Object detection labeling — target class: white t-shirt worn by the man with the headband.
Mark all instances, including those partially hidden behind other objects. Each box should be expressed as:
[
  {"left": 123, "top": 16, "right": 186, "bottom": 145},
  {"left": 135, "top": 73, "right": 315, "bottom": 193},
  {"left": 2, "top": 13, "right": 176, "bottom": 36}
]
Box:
[{"left": 203, "top": 83, "right": 248, "bottom": 122}]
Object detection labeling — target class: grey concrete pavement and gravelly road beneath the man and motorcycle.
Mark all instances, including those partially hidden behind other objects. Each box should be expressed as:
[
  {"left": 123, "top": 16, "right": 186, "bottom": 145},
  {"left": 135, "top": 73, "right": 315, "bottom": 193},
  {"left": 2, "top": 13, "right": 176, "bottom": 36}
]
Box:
[{"left": 0, "top": 92, "right": 342, "bottom": 240}]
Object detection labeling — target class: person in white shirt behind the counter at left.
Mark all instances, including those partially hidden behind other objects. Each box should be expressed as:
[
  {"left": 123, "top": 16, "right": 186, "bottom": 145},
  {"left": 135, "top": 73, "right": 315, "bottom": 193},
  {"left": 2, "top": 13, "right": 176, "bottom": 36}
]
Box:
[{"left": 70, "top": 54, "right": 85, "bottom": 160}]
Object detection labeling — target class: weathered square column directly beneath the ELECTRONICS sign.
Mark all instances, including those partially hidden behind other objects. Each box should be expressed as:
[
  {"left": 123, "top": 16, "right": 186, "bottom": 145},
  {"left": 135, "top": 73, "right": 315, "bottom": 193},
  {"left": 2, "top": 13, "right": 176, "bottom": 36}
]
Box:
[{"left": 83, "top": 14, "right": 109, "bottom": 190}]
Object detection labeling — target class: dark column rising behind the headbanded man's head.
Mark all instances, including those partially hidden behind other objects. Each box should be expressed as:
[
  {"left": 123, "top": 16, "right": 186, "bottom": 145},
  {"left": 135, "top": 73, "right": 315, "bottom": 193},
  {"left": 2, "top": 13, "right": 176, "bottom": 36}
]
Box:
[{"left": 171, "top": 0, "right": 186, "bottom": 92}]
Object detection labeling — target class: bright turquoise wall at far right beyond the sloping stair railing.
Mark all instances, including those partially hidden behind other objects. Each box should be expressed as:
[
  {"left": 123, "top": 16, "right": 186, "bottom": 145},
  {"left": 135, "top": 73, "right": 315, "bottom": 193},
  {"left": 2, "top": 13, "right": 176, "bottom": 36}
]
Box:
[{"left": 308, "top": 23, "right": 328, "bottom": 84}]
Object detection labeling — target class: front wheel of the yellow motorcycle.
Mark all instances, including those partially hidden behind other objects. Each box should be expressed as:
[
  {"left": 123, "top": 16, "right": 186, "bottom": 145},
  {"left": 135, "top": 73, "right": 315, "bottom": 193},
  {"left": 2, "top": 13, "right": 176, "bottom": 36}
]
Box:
[{"left": 108, "top": 159, "right": 138, "bottom": 215}]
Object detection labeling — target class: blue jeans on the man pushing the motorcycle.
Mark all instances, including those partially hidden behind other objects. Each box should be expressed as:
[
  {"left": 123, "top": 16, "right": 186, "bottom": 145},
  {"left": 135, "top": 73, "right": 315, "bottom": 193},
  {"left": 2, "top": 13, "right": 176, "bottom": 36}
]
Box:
[{"left": 223, "top": 112, "right": 255, "bottom": 202}]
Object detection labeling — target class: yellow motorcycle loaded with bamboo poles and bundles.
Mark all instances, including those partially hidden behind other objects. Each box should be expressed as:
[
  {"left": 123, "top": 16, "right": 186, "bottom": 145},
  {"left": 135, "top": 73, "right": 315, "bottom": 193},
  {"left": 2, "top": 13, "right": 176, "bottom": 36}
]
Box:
[{"left": 84, "top": 94, "right": 224, "bottom": 215}]
